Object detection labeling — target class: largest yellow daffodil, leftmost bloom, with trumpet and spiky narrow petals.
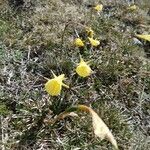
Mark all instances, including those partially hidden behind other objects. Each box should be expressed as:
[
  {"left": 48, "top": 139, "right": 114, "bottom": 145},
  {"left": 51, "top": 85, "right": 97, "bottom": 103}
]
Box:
[{"left": 45, "top": 72, "right": 69, "bottom": 96}]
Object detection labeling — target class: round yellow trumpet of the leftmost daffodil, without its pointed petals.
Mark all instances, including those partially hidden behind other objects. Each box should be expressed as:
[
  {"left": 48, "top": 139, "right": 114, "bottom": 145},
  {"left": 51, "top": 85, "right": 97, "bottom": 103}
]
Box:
[{"left": 45, "top": 79, "right": 62, "bottom": 96}]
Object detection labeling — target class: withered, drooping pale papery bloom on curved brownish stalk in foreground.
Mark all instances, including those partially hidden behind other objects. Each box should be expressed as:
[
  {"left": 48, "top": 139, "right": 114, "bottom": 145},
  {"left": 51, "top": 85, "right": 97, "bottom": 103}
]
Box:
[{"left": 53, "top": 105, "right": 118, "bottom": 150}]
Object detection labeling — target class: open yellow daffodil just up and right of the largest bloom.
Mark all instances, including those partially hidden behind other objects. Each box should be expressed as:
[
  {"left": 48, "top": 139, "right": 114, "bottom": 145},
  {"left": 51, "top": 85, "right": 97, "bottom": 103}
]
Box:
[{"left": 76, "top": 58, "right": 92, "bottom": 77}]
